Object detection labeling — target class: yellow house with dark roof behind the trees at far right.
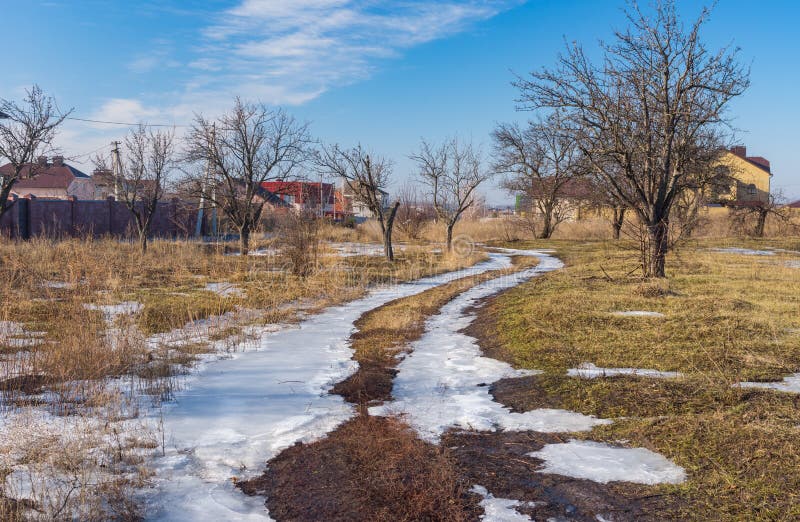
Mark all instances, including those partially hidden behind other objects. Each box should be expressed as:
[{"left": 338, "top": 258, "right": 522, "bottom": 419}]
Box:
[{"left": 709, "top": 145, "right": 772, "bottom": 205}]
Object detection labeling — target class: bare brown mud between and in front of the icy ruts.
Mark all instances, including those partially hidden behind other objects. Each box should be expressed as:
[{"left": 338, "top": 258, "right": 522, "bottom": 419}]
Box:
[{"left": 239, "top": 250, "right": 670, "bottom": 521}]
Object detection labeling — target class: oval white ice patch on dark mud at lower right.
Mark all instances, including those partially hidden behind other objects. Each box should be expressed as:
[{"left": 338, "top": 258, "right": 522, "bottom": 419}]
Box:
[{"left": 528, "top": 440, "right": 686, "bottom": 484}]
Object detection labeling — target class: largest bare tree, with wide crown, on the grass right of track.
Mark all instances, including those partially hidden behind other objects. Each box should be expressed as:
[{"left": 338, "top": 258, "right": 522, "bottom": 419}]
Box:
[{"left": 516, "top": 0, "right": 749, "bottom": 277}]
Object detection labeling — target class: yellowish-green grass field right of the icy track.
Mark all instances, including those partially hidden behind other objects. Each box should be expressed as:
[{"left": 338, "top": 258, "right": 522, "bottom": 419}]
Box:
[{"left": 482, "top": 240, "right": 800, "bottom": 520}]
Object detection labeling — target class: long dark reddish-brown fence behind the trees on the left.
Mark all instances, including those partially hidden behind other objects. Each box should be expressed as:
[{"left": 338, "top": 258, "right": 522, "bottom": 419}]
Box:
[{"left": 0, "top": 196, "right": 197, "bottom": 239}]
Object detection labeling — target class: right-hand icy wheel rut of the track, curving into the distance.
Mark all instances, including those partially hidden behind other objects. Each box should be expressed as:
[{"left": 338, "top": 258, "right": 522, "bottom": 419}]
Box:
[{"left": 370, "top": 250, "right": 611, "bottom": 442}]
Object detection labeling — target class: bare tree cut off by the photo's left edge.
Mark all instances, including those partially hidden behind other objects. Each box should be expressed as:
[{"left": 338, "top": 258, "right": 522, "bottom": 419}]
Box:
[{"left": 0, "top": 85, "right": 72, "bottom": 217}]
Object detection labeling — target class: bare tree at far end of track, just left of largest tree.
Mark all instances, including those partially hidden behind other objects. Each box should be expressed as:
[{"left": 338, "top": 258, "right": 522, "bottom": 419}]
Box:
[{"left": 492, "top": 111, "right": 586, "bottom": 239}]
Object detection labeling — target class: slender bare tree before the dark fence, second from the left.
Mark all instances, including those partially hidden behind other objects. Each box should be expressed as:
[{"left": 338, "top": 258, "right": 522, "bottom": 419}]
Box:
[{"left": 94, "top": 125, "right": 178, "bottom": 255}]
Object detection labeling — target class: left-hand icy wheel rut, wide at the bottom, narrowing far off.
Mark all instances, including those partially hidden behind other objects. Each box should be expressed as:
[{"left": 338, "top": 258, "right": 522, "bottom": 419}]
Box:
[{"left": 145, "top": 254, "right": 511, "bottom": 520}]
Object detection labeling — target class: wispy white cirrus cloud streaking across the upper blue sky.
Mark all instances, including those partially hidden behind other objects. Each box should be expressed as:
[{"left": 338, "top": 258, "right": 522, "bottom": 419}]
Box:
[{"left": 184, "top": 0, "right": 522, "bottom": 104}]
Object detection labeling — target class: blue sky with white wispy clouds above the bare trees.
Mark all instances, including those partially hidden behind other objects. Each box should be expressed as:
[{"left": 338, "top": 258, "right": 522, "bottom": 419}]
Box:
[{"left": 0, "top": 0, "right": 800, "bottom": 205}]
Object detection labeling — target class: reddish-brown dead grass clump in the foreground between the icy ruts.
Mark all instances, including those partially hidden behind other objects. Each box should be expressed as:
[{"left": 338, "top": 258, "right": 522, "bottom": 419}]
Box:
[{"left": 239, "top": 416, "right": 481, "bottom": 522}]
